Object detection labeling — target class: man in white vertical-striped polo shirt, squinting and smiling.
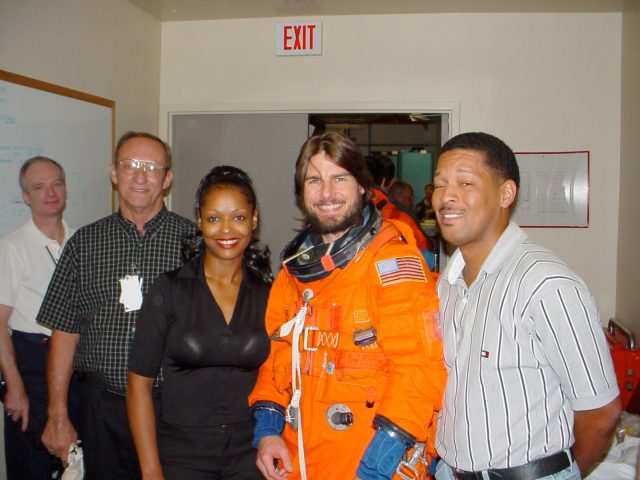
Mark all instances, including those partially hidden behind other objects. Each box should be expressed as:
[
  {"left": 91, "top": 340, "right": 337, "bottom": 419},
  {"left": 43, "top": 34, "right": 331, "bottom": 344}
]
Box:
[{"left": 433, "top": 133, "right": 620, "bottom": 480}]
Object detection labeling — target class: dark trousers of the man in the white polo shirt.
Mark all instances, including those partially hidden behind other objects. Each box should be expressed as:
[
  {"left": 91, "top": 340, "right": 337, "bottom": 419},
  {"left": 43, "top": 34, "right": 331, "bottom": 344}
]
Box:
[{"left": 4, "top": 332, "right": 61, "bottom": 480}]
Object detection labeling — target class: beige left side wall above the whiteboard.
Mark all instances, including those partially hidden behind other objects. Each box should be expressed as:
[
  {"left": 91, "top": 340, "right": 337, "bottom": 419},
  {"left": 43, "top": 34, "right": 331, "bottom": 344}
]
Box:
[{"left": 0, "top": 0, "right": 160, "bottom": 137}]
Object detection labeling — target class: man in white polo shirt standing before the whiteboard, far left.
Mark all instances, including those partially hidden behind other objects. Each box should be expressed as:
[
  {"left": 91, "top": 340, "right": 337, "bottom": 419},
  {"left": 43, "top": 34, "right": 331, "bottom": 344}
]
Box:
[{"left": 0, "top": 157, "right": 73, "bottom": 480}]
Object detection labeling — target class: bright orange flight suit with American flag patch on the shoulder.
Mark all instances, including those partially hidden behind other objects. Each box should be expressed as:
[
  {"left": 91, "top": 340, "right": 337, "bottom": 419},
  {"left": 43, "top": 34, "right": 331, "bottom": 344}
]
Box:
[{"left": 249, "top": 221, "right": 446, "bottom": 480}]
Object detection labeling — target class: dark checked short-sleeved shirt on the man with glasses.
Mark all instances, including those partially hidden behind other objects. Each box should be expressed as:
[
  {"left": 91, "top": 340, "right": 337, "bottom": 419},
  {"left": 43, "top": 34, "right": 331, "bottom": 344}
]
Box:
[{"left": 37, "top": 208, "right": 195, "bottom": 395}]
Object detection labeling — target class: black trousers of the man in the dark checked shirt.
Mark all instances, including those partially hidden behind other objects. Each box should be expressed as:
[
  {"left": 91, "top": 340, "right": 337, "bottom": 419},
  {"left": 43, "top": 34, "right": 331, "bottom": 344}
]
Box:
[{"left": 78, "top": 379, "right": 158, "bottom": 480}]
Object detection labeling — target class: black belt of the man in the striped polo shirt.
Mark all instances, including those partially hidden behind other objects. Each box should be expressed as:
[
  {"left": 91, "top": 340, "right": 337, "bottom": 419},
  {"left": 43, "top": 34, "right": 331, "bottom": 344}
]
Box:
[{"left": 451, "top": 452, "right": 571, "bottom": 480}]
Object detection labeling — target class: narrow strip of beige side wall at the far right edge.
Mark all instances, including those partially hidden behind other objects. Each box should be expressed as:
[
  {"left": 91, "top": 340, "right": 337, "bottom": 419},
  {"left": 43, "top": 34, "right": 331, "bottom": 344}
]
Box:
[{"left": 616, "top": 1, "right": 640, "bottom": 336}]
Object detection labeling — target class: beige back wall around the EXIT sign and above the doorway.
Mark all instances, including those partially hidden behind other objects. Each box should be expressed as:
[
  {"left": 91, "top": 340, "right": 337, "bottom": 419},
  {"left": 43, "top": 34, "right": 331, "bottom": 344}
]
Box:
[{"left": 160, "top": 13, "right": 622, "bottom": 320}]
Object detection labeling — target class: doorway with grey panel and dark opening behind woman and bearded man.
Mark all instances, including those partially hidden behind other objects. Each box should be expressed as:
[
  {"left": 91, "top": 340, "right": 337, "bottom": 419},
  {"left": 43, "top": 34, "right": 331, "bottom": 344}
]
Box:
[{"left": 169, "top": 112, "right": 450, "bottom": 271}]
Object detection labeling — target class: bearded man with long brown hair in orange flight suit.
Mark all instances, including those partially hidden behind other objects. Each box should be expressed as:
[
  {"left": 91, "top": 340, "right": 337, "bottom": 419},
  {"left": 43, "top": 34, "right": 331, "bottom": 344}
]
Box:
[{"left": 249, "top": 132, "right": 446, "bottom": 480}]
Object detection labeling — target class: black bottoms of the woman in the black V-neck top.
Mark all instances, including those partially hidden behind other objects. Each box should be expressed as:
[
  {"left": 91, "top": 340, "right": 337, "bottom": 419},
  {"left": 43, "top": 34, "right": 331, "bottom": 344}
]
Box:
[{"left": 158, "top": 420, "right": 263, "bottom": 480}]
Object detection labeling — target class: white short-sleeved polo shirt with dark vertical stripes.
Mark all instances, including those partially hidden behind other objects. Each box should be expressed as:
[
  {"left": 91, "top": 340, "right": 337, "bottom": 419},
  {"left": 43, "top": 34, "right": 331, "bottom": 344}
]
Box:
[{"left": 436, "top": 222, "right": 618, "bottom": 471}]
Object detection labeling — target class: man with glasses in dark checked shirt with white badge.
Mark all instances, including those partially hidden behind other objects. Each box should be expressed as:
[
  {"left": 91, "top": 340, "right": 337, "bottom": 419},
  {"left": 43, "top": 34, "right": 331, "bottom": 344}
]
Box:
[{"left": 38, "top": 132, "right": 195, "bottom": 480}]
